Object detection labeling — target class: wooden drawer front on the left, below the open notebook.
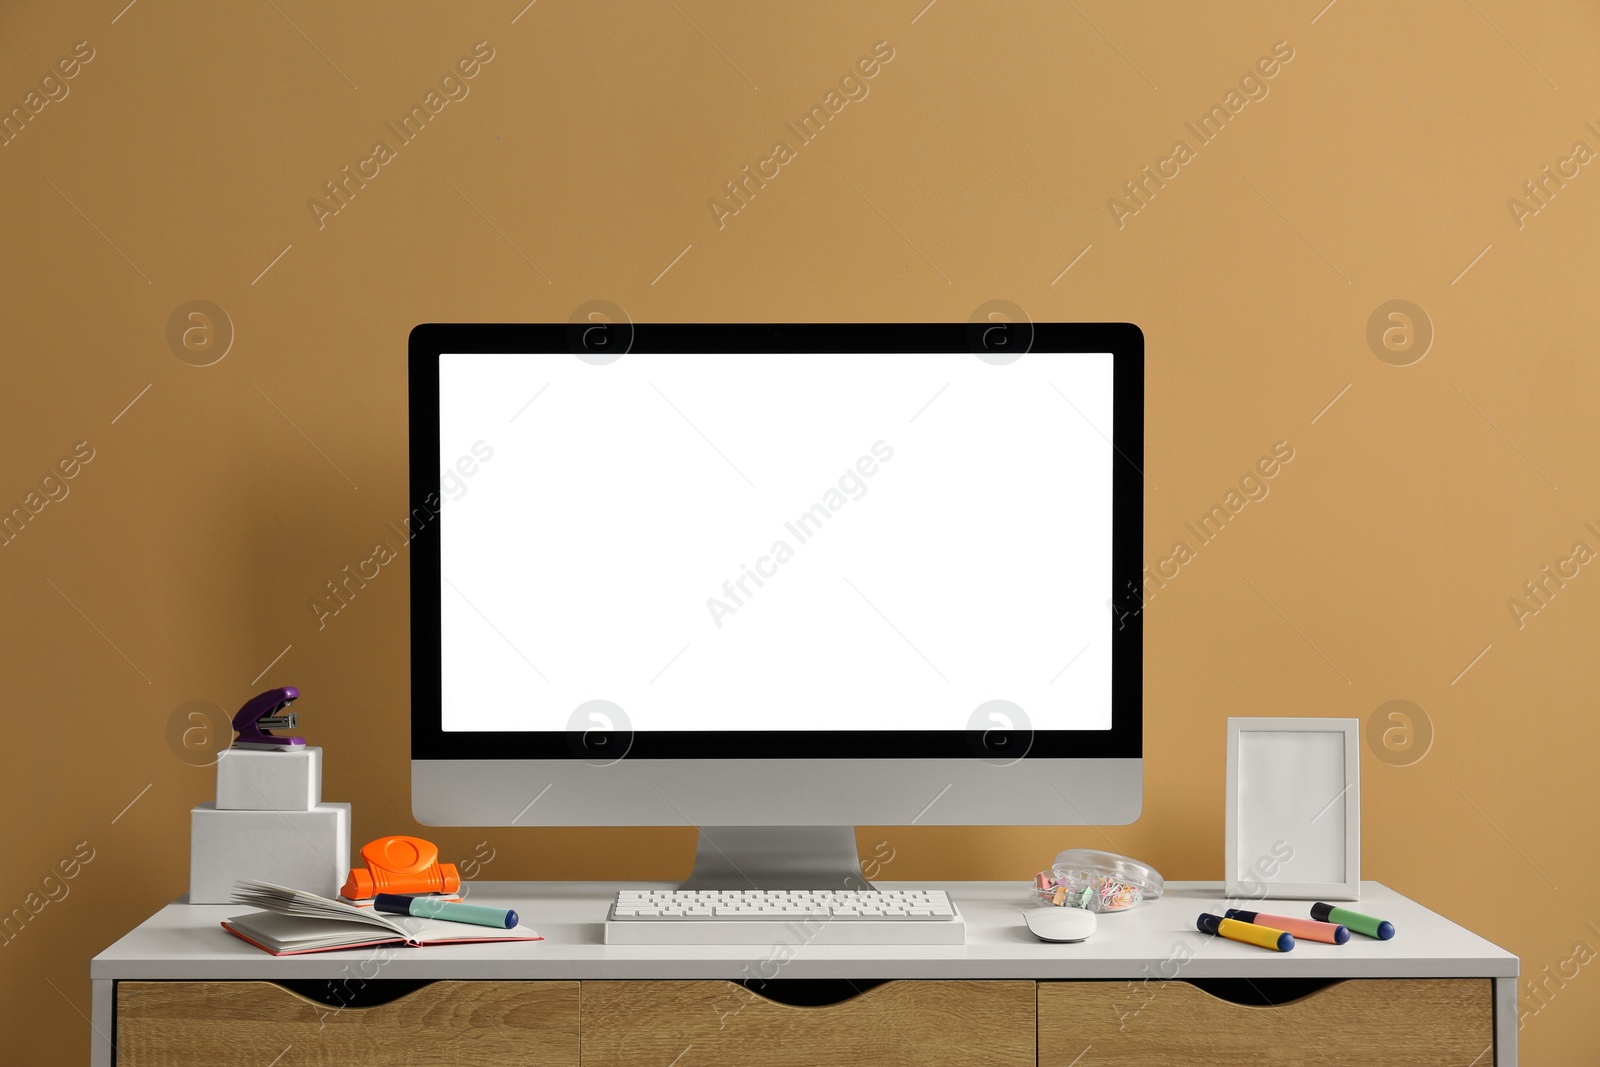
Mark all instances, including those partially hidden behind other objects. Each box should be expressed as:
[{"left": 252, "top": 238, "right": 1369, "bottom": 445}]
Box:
[{"left": 117, "top": 981, "right": 579, "bottom": 1067}]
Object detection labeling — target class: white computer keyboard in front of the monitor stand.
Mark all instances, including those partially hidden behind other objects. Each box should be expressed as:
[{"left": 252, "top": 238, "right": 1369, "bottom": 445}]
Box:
[{"left": 605, "top": 889, "right": 966, "bottom": 947}]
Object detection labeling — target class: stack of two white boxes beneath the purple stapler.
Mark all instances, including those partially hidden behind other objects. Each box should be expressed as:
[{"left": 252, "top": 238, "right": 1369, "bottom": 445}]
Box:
[{"left": 189, "top": 745, "right": 350, "bottom": 904}]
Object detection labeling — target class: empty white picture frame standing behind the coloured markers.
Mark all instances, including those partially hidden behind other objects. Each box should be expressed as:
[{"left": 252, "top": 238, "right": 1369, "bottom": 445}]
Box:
[{"left": 1222, "top": 717, "right": 1362, "bottom": 901}]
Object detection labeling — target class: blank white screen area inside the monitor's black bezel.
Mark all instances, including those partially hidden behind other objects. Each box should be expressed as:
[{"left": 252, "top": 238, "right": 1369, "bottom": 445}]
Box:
[{"left": 438, "top": 354, "right": 1112, "bottom": 731}]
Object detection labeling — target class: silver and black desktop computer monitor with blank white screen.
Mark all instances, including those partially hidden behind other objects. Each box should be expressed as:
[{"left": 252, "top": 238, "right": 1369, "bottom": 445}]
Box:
[{"left": 410, "top": 322, "right": 1144, "bottom": 888}]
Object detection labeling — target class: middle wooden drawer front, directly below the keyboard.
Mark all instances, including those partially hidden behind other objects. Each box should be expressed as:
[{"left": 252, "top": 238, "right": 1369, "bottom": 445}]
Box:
[{"left": 582, "top": 981, "right": 1037, "bottom": 1067}]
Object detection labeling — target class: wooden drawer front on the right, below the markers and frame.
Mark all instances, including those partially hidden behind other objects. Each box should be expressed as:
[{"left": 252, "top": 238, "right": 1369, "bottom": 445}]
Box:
[{"left": 1038, "top": 979, "right": 1494, "bottom": 1067}]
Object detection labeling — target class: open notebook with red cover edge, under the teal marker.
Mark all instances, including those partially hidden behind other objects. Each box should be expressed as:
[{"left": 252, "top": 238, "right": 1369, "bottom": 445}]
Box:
[{"left": 222, "top": 880, "right": 542, "bottom": 957}]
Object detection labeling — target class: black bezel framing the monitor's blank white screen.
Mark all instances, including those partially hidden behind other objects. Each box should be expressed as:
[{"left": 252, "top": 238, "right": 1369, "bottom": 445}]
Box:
[{"left": 408, "top": 323, "right": 1144, "bottom": 760}]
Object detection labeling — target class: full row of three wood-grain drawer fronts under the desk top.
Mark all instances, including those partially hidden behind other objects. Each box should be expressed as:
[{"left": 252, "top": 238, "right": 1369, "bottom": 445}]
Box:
[{"left": 117, "top": 979, "right": 1494, "bottom": 1067}]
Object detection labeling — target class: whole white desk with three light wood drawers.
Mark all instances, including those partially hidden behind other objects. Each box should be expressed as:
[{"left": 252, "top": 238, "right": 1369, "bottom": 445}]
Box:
[{"left": 93, "top": 881, "right": 1518, "bottom": 1067}]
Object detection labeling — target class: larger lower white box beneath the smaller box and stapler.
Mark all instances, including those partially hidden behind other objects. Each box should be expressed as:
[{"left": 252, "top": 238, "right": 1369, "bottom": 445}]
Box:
[{"left": 189, "top": 803, "right": 350, "bottom": 904}]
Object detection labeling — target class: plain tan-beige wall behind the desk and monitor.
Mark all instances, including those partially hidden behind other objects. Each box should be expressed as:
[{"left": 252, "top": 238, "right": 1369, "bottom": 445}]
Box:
[{"left": 0, "top": 0, "right": 1600, "bottom": 1064}]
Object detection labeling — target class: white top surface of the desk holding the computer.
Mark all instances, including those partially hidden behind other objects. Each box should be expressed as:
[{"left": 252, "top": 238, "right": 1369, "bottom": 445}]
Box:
[{"left": 90, "top": 881, "right": 1517, "bottom": 981}]
